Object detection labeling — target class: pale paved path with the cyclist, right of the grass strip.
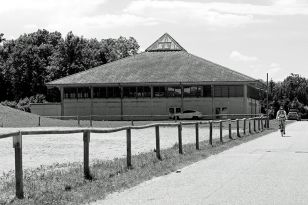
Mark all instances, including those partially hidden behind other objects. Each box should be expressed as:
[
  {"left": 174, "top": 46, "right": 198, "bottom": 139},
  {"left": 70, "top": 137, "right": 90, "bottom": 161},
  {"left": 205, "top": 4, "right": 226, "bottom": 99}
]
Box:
[{"left": 92, "top": 122, "right": 308, "bottom": 205}]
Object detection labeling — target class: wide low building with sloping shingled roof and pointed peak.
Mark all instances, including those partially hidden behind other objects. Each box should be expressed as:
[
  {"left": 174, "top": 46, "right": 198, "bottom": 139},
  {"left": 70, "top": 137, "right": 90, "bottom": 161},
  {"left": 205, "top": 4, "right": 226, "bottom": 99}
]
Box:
[{"left": 31, "top": 33, "right": 264, "bottom": 119}]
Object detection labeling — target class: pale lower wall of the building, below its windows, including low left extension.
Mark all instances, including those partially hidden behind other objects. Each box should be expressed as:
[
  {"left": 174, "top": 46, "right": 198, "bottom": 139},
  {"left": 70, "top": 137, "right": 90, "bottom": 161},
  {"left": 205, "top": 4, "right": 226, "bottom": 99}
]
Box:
[{"left": 32, "top": 97, "right": 261, "bottom": 120}]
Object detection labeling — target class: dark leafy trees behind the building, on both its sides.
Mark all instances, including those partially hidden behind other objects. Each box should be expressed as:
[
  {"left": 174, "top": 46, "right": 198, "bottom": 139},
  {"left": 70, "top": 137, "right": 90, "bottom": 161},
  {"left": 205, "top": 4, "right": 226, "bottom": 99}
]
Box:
[{"left": 0, "top": 30, "right": 308, "bottom": 117}]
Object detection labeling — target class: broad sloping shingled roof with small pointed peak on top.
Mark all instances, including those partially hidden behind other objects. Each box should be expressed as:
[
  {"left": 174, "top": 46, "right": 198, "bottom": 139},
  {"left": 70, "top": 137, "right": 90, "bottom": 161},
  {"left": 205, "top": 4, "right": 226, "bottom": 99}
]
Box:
[{"left": 47, "top": 34, "right": 256, "bottom": 86}]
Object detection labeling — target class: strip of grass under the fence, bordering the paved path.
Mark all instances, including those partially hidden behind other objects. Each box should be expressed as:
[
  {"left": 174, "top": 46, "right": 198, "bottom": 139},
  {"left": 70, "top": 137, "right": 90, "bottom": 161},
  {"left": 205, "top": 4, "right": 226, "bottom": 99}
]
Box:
[{"left": 0, "top": 121, "right": 286, "bottom": 204}]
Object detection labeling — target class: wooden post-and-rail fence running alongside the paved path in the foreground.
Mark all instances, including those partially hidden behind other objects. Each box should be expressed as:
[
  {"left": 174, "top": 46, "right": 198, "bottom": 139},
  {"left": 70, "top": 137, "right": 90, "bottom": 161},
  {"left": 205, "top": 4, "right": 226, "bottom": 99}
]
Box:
[{"left": 0, "top": 116, "right": 268, "bottom": 199}]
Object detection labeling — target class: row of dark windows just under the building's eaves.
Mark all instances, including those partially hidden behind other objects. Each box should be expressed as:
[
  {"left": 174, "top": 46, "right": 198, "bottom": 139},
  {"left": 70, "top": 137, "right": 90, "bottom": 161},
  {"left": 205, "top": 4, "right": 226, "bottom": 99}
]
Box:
[{"left": 64, "top": 85, "right": 244, "bottom": 99}]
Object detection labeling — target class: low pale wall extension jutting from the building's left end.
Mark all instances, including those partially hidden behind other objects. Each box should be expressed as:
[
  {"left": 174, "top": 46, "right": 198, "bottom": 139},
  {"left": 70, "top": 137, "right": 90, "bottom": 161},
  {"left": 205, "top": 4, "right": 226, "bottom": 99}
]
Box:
[{"left": 30, "top": 103, "right": 61, "bottom": 116}]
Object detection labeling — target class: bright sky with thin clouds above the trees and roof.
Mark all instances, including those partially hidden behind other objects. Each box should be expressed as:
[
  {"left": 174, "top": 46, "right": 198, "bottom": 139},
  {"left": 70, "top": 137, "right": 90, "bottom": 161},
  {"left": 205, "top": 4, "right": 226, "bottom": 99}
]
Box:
[{"left": 0, "top": 0, "right": 308, "bottom": 81}]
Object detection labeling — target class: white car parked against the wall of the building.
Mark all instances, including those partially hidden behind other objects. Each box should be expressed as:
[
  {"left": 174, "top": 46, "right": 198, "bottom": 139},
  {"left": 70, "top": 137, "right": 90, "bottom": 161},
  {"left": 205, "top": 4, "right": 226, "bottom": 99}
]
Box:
[{"left": 169, "top": 107, "right": 202, "bottom": 120}]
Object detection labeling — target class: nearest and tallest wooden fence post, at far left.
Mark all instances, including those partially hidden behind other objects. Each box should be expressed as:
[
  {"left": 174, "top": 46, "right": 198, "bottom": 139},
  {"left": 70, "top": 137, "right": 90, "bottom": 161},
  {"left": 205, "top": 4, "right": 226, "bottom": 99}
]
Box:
[{"left": 13, "top": 132, "right": 24, "bottom": 199}]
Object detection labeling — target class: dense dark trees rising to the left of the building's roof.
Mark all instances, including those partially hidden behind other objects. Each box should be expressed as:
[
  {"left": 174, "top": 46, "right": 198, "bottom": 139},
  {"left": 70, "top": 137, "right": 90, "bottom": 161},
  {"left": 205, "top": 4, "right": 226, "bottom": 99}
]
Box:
[{"left": 0, "top": 30, "right": 139, "bottom": 102}]
